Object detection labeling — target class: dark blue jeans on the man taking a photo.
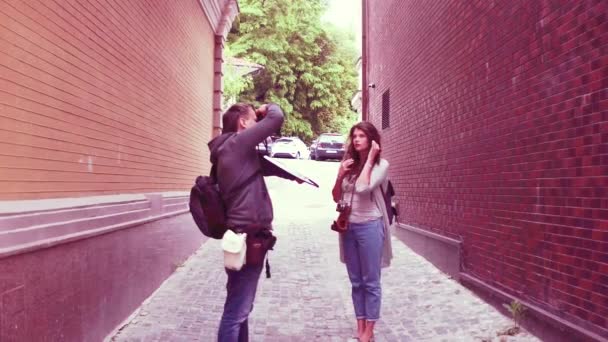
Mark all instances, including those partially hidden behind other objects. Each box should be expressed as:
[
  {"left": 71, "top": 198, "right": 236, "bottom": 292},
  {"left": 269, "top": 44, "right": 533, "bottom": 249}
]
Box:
[{"left": 217, "top": 265, "right": 264, "bottom": 342}]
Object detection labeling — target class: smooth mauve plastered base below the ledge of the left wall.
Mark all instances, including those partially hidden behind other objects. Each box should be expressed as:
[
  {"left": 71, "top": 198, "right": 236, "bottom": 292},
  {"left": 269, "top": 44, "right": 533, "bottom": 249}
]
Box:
[{"left": 0, "top": 215, "right": 203, "bottom": 342}]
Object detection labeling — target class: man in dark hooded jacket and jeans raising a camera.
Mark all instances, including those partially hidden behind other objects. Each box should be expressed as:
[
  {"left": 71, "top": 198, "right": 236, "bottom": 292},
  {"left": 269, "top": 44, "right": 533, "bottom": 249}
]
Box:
[{"left": 209, "top": 103, "right": 293, "bottom": 342}]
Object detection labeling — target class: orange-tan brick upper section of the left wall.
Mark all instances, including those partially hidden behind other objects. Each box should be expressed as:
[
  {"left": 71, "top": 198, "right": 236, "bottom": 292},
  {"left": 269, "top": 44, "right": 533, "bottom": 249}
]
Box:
[{"left": 0, "top": 0, "right": 214, "bottom": 199}]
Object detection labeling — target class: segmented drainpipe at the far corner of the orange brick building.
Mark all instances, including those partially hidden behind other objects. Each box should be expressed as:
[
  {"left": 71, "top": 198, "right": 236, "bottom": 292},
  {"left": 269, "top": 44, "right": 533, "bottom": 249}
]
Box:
[{"left": 211, "top": 0, "right": 239, "bottom": 137}]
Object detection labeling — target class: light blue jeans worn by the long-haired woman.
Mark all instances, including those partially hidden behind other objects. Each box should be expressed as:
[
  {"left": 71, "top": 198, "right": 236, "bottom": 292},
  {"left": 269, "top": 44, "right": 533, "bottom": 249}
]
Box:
[{"left": 344, "top": 219, "right": 384, "bottom": 321}]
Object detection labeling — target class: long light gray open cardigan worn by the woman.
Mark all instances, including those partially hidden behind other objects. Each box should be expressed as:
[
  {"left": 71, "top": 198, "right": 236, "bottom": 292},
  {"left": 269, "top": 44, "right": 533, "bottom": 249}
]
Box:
[{"left": 339, "top": 159, "right": 393, "bottom": 267}]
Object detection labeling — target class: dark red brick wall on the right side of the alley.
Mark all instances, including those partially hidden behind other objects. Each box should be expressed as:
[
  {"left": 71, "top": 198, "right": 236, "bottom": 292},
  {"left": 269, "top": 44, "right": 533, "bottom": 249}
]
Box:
[{"left": 368, "top": 0, "right": 608, "bottom": 333}]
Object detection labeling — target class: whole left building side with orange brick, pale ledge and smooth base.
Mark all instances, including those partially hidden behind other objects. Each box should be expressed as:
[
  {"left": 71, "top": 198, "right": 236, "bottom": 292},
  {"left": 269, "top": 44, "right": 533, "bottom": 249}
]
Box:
[{"left": 0, "top": 0, "right": 238, "bottom": 341}]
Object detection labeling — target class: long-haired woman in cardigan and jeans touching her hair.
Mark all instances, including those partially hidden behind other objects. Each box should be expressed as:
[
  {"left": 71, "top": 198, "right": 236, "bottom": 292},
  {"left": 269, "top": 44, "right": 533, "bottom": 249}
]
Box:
[{"left": 332, "top": 122, "right": 392, "bottom": 342}]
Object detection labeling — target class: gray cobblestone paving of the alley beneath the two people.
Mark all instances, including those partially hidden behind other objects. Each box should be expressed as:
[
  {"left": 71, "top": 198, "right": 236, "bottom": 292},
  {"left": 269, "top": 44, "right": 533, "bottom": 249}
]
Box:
[{"left": 112, "top": 194, "right": 537, "bottom": 342}]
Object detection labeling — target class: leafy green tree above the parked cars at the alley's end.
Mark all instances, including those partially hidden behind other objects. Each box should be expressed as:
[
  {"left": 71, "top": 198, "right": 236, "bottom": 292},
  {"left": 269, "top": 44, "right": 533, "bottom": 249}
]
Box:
[{"left": 228, "top": 0, "right": 357, "bottom": 141}]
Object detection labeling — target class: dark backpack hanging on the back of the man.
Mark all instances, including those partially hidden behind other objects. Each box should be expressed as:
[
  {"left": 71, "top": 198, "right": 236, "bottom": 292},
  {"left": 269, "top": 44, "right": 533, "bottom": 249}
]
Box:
[{"left": 189, "top": 165, "right": 228, "bottom": 239}]
